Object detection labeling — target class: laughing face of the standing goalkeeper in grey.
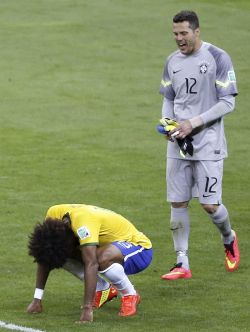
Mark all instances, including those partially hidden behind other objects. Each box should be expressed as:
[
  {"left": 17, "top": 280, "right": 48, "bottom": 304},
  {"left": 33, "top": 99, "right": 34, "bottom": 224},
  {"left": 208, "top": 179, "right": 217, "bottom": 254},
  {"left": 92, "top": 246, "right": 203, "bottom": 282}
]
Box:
[{"left": 173, "top": 21, "right": 201, "bottom": 55}]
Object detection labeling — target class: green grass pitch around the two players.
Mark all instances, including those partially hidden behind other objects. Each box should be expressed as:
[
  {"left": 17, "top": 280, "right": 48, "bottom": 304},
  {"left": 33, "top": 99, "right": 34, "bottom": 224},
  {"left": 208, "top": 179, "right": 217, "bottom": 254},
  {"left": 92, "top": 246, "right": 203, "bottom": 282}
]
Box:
[{"left": 0, "top": 0, "right": 250, "bottom": 332}]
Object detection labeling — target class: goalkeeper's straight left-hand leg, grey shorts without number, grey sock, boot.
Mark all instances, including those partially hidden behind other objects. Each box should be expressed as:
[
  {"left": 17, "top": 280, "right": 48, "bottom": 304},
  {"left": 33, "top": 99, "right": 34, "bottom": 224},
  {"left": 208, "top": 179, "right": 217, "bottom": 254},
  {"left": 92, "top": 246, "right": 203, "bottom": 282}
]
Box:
[{"left": 161, "top": 159, "right": 194, "bottom": 280}]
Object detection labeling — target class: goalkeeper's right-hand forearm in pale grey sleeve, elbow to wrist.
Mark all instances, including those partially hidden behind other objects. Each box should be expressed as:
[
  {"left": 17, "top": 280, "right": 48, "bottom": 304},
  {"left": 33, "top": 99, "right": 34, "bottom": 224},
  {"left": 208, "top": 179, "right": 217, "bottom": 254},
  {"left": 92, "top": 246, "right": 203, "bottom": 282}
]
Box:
[{"left": 189, "top": 96, "right": 235, "bottom": 129}]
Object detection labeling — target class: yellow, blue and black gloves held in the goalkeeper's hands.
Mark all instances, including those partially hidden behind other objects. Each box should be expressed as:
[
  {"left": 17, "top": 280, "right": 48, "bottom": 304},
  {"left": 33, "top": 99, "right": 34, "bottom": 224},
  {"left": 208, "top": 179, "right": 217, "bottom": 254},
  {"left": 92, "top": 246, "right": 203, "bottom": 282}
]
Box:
[{"left": 157, "top": 118, "right": 194, "bottom": 158}]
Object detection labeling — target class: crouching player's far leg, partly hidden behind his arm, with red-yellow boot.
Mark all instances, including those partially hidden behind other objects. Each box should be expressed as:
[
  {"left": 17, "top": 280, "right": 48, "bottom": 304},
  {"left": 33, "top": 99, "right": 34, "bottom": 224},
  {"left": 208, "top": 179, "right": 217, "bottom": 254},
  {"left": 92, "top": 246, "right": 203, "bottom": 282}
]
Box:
[{"left": 63, "top": 258, "right": 118, "bottom": 308}]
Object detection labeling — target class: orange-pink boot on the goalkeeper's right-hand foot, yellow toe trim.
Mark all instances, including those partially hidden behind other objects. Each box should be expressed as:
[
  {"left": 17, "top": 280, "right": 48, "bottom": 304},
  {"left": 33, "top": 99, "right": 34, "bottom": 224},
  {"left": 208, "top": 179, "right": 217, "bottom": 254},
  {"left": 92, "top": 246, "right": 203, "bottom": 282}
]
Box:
[{"left": 224, "top": 231, "right": 240, "bottom": 272}]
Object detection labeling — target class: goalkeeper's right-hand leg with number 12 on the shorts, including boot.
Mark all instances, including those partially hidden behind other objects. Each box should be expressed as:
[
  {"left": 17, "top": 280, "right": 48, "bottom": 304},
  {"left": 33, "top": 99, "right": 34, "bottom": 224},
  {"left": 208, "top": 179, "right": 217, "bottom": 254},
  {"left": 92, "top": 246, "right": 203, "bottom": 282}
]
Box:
[{"left": 197, "top": 160, "right": 240, "bottom": 272}]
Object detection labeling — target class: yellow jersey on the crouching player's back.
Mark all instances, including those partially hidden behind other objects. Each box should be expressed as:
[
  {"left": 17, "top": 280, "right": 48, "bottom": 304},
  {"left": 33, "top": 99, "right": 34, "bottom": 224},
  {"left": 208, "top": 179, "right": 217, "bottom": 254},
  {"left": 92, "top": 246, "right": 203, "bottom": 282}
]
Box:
[{"left": 46, "top": 204, "right": 152, "bottom": 249}]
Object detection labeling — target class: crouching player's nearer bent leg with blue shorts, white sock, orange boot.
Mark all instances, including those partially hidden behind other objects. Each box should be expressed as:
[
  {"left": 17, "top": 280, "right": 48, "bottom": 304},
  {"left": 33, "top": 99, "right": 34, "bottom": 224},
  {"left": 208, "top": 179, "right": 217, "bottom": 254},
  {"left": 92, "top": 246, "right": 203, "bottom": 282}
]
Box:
[{"left": 98, "top": 242, "right": 152, "bottom": 316}]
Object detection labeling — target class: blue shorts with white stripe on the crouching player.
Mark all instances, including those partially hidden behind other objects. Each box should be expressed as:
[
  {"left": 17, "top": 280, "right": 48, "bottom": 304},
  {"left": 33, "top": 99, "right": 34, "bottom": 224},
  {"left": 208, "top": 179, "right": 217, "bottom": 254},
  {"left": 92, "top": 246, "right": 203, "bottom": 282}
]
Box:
[{"left": 112, "top": 241, "right": 153, "bottom": 274}]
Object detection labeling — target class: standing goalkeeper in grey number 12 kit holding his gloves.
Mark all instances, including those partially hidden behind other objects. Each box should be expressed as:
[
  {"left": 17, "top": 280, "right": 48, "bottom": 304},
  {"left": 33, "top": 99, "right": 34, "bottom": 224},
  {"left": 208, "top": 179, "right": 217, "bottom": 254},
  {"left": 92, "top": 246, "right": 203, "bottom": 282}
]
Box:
[{"left": 158, "top": 11, "right": 240, "bottom": 280}]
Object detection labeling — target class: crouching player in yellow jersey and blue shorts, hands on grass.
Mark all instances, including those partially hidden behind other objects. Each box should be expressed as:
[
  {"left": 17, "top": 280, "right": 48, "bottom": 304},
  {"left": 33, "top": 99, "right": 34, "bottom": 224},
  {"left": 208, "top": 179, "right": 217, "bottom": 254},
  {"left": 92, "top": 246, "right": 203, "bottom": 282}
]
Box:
[{"left": 27, "top": 204, "right": 152, "bottom": 323}]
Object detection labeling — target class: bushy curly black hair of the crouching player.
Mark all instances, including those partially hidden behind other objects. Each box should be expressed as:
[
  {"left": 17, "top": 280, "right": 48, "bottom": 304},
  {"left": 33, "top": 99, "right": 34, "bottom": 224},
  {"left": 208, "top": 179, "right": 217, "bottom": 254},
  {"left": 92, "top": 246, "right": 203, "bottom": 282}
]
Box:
[{"left": 28, "top": 218, "right": 79, "bottom": 270}]
